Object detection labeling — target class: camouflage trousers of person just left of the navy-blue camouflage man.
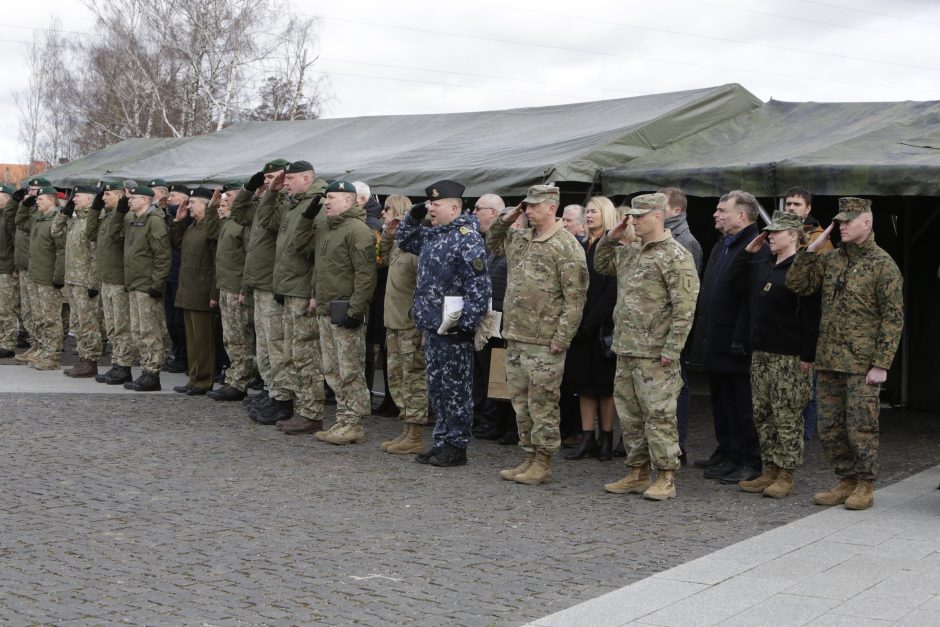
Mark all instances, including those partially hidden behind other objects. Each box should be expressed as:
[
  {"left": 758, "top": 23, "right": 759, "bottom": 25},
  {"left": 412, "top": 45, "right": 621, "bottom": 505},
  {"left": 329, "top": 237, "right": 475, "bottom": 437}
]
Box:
[{"left": 385, "top": 328, "right": 428, "bottom": 425}]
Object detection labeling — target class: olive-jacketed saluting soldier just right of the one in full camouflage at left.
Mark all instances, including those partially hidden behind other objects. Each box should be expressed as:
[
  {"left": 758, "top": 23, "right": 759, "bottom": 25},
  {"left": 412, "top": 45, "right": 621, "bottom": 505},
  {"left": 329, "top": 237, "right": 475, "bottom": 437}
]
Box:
[{"left": 85, "top": 181, "right": 136, "bottom": 385}]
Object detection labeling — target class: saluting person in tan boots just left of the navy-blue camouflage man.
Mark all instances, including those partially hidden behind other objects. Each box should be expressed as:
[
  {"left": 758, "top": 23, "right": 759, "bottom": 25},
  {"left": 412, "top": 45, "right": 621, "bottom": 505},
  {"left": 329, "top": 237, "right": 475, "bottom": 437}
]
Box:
[{"left": 379, "top": 196, "right": 428, "bottom": 455}]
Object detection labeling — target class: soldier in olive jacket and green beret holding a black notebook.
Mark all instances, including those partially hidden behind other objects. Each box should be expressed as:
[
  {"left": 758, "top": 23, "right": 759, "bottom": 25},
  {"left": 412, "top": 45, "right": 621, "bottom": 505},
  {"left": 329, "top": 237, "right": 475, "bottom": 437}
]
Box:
[{"left": 308, "top": 180, "right": 376, "bottom": 444}]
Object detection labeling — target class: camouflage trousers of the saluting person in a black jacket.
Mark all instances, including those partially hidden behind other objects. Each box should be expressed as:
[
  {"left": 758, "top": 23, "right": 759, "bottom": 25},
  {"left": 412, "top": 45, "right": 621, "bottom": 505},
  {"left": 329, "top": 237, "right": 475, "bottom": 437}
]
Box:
[{"left": 751, "top": 351, "right": 813, "bottom": 470}]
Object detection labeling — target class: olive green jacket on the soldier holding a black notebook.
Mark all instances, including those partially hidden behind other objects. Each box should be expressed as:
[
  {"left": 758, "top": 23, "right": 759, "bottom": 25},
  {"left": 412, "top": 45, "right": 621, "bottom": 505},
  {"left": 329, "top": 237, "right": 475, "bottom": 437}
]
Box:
[{"left": 308, "top": 204, "right": 376, "bottom": 320}]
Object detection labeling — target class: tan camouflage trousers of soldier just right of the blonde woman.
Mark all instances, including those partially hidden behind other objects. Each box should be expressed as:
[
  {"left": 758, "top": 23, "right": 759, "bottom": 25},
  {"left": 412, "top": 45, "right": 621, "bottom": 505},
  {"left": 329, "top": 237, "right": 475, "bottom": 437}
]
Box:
[{"left": 614, "top": 355, "right": 682, "bottom": 470}]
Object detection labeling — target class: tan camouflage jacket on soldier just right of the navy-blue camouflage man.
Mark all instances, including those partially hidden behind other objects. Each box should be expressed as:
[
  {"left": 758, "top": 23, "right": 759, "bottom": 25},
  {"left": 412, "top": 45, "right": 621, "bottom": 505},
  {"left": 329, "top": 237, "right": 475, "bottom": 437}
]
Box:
[{"left": 486, "top": 220, "right": 588, "bottom": 349}]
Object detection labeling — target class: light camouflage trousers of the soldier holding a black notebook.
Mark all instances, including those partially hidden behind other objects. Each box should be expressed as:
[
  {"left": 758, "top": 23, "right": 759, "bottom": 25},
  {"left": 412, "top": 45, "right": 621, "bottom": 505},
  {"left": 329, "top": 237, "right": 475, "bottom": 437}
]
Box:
[{"left": 317, "top": 315, "right": 372, "bottom": 425}]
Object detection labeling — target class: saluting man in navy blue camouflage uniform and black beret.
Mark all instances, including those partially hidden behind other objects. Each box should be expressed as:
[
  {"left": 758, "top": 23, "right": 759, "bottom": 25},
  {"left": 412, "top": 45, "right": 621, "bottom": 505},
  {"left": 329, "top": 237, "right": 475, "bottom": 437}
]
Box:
[{"left": 395, "top": 180, "right": 492, "bottom": 467}]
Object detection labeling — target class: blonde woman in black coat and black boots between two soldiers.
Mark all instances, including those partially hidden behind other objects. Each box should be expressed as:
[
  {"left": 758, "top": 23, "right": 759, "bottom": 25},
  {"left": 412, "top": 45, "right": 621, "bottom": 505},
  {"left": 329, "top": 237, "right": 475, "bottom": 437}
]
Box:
[{"left": 565, "top": 196, "right": 619, "bottom": 461}]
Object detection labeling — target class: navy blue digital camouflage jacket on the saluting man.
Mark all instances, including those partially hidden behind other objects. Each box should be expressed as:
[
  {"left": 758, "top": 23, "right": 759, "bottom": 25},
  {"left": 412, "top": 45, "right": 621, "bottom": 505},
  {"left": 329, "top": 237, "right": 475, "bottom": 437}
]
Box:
[{"left": 395, "top": 214, "right": 492, "bottom": 333}]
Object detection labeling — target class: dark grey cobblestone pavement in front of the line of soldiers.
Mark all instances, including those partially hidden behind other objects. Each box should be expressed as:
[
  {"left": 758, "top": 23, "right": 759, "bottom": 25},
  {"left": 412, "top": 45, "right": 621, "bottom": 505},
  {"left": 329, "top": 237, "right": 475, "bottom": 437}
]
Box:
[{"left": 0, "top": 394, "right": 940, "bottom": 625}]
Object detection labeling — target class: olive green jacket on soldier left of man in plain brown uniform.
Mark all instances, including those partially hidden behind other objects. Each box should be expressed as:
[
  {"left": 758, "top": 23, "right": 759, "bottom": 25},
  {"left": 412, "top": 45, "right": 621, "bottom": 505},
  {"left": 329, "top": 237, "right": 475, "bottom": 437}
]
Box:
[{"left": 123, "top": 206, "right": 170, "bottom": 292}]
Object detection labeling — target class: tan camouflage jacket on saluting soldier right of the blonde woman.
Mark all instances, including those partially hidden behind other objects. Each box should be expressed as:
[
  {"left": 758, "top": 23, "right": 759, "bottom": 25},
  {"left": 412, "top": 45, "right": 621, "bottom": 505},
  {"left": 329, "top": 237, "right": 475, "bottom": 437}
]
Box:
[{"left": 594, "top": 231, "right": 699, "bottom": 361}]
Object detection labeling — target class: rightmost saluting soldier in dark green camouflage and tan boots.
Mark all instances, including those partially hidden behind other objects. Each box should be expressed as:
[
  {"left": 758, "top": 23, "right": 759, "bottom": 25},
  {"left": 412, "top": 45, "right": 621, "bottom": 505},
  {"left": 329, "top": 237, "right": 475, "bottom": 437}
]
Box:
[{"left": 787, "top": 197, "right": 904, "bottom": 509}]
